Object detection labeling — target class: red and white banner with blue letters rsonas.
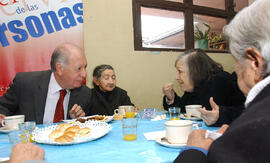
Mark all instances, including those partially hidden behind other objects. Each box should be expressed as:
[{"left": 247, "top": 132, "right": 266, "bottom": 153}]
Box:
[{"left": 0, "top": 0, "right": 83, "bottom": 96}]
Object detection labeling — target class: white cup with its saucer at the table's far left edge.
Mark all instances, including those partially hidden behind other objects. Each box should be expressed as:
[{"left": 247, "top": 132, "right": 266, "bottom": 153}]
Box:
[{"left": 0, "top": 115, "right": 24, "bottom": 133}]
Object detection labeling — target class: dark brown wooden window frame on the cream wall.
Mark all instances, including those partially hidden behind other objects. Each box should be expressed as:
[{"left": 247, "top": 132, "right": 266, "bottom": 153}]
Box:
[{"left": 132, "top": 0, "right": 236, "bottom": 53}]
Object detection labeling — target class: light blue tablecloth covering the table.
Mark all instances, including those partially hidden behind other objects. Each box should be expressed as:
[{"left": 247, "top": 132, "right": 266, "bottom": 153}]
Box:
[{"left": 0, "top": 116, "right": 218, "bottom": 163}]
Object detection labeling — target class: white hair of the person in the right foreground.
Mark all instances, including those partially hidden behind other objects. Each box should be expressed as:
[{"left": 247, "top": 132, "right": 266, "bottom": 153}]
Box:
[{"left": 223, "top": 0, "right": 270, "bottom": 77}]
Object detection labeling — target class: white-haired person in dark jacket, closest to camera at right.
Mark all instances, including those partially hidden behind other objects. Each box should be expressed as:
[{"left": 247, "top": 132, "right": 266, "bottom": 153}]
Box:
[{"left": 175, "top": 0, "right": 270, "bottom": 163}]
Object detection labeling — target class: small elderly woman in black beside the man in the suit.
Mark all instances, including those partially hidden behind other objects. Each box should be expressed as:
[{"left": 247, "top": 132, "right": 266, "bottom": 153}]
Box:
[{"left": 87, "top": 64, "right": 133, "bottom": 115}]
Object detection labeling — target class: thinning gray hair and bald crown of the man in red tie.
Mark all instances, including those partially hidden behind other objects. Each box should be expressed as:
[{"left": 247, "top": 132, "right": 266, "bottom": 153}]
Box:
[{"left": 51, "top": 46, "right": 68, "bottom": 72}]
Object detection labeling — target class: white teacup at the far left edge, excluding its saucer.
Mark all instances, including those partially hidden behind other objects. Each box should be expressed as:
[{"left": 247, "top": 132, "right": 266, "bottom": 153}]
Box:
[{"left": 2, "top": 115, "right": 24, "bottom": 129}]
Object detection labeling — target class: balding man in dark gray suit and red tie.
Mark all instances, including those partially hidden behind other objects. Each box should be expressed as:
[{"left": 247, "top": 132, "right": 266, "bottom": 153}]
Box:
[{"left": 0, "top": 43, "right": 91, "bottom": 124}]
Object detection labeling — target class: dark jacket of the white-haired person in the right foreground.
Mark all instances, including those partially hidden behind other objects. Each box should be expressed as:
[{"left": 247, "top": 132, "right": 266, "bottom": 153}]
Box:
[{"left": 175, "top": 84, "right": 270, "bottom": 163}]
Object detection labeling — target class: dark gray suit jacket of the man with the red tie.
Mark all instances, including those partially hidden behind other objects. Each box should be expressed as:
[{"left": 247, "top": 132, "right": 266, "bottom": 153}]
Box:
[{"left": 0, "top": 70, "right": 91, "bottom": 124}]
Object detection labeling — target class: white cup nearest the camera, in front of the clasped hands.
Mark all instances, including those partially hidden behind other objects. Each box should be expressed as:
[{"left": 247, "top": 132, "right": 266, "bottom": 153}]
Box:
[{"left": 165, "top": 120, "right": 193, "bottom": 144}]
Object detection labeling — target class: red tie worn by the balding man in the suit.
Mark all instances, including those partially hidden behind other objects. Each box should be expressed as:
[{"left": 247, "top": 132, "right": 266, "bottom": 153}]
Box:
[{"left": 53, "top": 89, "right": 67, "bottom": 123}]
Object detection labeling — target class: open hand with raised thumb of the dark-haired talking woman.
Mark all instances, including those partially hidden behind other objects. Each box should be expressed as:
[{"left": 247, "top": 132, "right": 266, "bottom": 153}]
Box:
[{"left": 199, "top": 97, "right": 219, "bottom": 125}]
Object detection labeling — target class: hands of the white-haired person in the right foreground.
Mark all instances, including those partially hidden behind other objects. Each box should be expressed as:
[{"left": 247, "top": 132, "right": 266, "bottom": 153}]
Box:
[{"left": 187, "top": 125, "right": 229, "bottom": 151}]
